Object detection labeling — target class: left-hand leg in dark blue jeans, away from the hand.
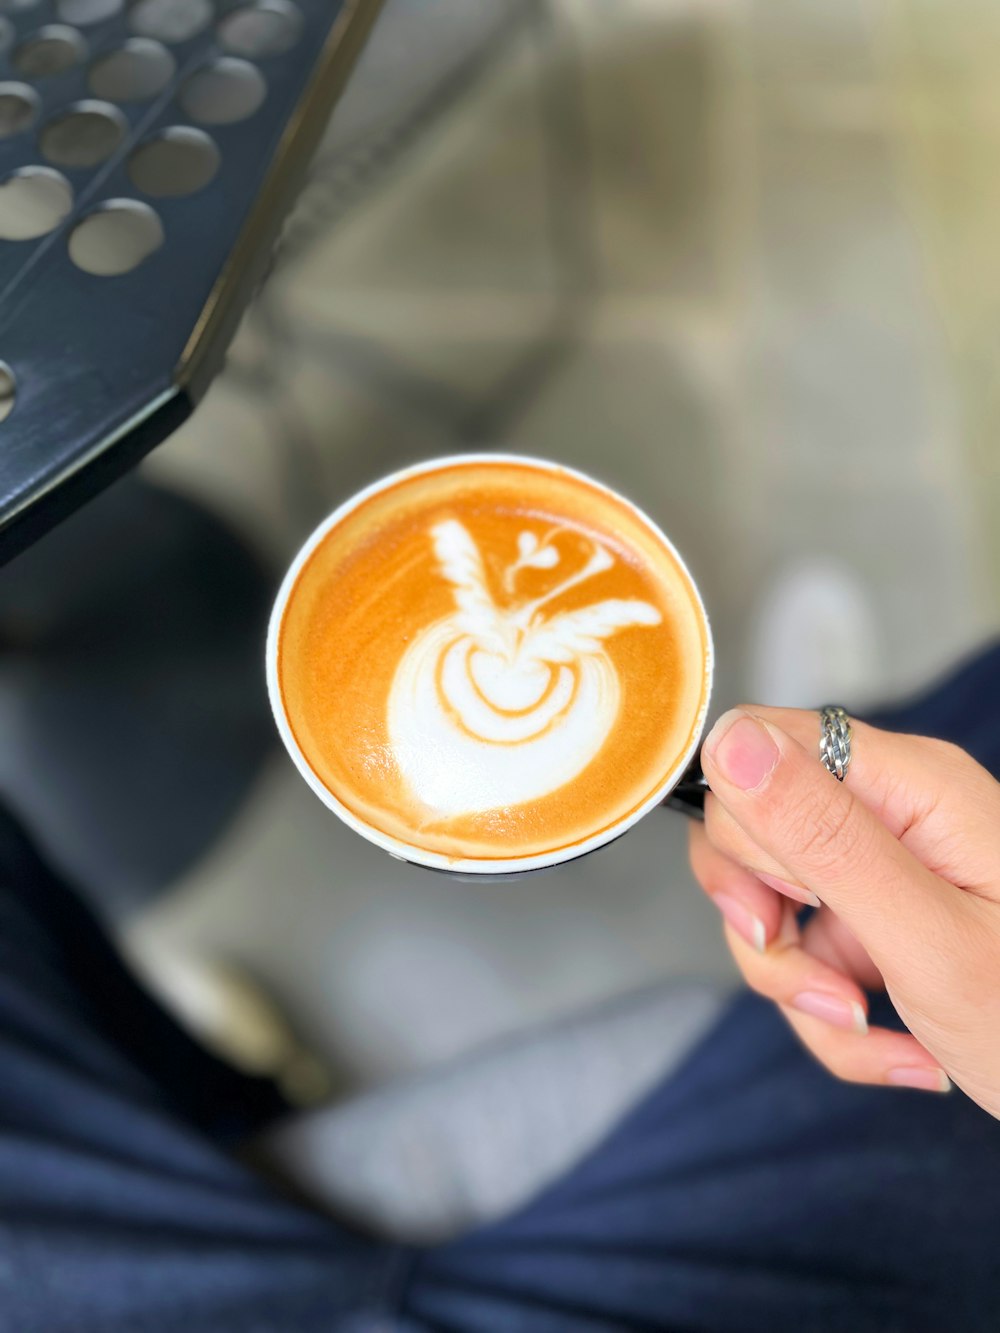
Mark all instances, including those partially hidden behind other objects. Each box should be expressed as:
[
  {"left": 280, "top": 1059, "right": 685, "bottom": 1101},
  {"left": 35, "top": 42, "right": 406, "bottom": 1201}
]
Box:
[{"left": 0, "top": 813, "right": 405, "bottom": 1333}]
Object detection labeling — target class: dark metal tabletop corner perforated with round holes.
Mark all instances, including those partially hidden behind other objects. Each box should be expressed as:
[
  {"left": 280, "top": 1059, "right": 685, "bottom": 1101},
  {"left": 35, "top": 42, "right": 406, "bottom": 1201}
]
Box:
[{"left": 0, "top": 0, "right": 379, "bottom": 559}]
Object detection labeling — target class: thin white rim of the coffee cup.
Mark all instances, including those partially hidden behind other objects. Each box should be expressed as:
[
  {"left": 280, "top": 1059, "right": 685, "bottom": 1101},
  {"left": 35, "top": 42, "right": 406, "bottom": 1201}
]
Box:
[{"left": 265, "top": 452, "right": 715, "bottom": 878}]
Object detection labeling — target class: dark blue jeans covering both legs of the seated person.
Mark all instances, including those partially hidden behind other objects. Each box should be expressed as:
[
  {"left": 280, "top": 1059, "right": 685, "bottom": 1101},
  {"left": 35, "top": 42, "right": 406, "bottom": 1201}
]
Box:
[{"left": 0, "top": 647, "right": 1000, "bottom": 1333}]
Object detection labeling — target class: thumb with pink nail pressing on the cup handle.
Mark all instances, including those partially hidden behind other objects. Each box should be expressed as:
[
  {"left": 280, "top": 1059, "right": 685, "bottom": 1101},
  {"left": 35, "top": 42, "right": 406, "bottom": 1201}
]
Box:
[{"left": 703, "top": 709, "right": 957, "bottom": 961}]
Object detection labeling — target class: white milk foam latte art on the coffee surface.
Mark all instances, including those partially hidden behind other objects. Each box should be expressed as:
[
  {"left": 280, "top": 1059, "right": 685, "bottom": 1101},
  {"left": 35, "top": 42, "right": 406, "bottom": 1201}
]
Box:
[{"left": 388, "top": 519, "right": 661, "bottom": 817}]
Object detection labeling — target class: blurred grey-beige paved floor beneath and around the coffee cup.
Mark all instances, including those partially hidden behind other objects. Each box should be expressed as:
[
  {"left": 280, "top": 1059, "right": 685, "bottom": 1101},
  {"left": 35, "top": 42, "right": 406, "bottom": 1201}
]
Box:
[{"left": 128, "top": 0, "right": 1000, "bottom": 1088}]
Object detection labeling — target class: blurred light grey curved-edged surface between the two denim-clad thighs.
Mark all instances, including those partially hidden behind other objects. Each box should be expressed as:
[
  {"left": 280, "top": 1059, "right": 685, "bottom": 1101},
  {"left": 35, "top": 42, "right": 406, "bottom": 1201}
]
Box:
[{"left": 253, "top": 978, "right": 733, "bottom": 1245}]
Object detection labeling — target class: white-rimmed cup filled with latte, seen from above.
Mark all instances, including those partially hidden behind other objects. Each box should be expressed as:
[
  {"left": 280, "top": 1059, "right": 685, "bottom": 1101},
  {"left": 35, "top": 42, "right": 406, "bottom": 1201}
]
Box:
[{"left": 267, "top": 455, "right": 713, "bottom": 876}]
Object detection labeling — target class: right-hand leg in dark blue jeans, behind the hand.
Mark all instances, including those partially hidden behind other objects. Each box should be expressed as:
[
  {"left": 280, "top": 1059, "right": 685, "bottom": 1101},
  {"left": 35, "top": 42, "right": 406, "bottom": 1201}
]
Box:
[{"left": 404, "top": 639, "right": 1000, "bottom": 1333}]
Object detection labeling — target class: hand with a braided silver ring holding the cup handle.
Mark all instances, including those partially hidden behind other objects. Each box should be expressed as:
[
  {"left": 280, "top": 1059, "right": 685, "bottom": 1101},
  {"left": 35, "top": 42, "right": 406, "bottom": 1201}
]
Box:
[{"left": 691, "top": 706, "right": 1000, "bottom": 1117}]
